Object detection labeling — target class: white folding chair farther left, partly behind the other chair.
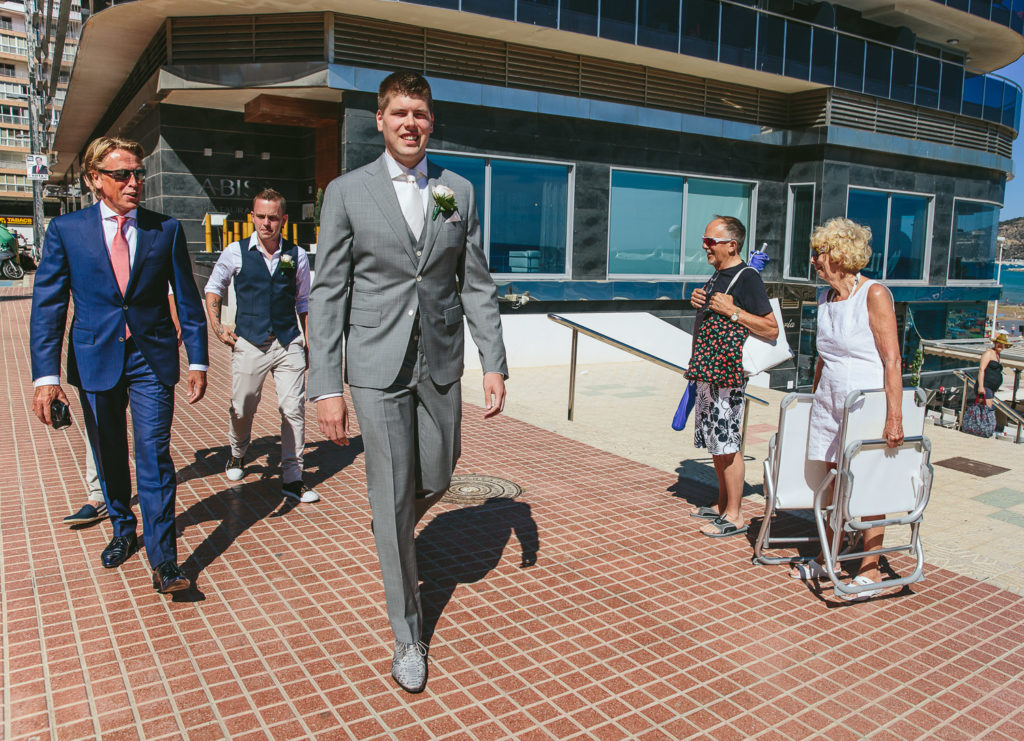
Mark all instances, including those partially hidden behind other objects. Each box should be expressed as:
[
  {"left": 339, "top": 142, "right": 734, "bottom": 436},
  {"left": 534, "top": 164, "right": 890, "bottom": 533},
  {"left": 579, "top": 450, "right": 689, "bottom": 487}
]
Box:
[{"left": 754, "top": 393, "right": 833, "bottom": 564}]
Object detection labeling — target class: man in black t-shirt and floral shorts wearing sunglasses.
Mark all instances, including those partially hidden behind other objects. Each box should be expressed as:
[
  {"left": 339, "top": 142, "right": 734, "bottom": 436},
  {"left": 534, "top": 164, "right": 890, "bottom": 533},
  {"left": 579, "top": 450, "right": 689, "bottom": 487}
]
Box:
[{"left": 688, "top": 216, "right": 778, "bottom": 537}]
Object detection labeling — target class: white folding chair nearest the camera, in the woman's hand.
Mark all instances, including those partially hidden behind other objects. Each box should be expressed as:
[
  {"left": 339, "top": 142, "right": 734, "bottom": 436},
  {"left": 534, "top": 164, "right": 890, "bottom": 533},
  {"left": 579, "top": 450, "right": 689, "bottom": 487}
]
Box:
[{"left": 813, "top": 388, "right": 932, "bottom": 596}]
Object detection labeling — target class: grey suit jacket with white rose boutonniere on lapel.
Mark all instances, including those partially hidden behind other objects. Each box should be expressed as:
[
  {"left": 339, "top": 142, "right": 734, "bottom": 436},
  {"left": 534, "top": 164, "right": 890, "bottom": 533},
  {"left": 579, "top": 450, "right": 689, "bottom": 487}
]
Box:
[{"left": 307, "top": 155, "right": 508, "bottom": 399}]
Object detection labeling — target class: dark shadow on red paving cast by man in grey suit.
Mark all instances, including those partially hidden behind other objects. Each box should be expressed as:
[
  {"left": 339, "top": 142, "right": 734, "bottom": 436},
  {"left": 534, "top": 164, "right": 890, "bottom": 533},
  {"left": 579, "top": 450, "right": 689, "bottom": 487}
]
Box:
[{"left": 416, "top": 499, "right": 540, "bottom": 644}]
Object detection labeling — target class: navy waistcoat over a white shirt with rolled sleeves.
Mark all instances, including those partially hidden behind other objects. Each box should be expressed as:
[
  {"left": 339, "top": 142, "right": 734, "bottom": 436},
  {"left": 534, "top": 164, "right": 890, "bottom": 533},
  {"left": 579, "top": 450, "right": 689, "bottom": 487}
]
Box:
[{"left": 234, "top": 239, "right": 299, "bottom": 347}]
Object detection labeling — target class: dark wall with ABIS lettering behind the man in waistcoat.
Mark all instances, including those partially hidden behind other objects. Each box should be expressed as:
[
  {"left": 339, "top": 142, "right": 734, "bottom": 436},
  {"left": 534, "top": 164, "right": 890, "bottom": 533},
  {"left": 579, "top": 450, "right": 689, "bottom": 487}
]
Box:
[{"left": 125, "top": 105, "right": 315, "bottom": 251}]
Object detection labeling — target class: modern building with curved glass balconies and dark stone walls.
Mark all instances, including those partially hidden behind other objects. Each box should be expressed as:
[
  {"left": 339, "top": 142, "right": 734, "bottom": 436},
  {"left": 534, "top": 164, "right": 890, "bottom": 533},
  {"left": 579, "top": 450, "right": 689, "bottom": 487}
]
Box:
[{"left": 56, "top": 0, "right": 1024, "bottom": 387}]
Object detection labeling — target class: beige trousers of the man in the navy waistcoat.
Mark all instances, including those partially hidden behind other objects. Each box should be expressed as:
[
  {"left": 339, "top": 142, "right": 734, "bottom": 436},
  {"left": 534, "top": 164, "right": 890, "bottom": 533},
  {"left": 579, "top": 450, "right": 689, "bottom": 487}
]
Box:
[{"left": 227, "top": 337, "right": 306, "bottom": 484}]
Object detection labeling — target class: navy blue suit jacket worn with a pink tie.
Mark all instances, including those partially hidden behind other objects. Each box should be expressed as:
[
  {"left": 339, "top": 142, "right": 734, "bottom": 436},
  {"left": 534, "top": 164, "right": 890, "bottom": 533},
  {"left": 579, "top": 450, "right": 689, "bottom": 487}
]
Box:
[{"left": 31, "top": 199, "right": 209, "bottom": 391}]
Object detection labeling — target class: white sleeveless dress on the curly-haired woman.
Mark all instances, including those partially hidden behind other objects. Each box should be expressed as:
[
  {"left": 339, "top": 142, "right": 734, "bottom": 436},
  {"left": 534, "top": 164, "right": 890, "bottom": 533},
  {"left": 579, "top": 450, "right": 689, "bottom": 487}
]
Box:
[{"left": 807, "top": 276, "right": 884, "bottom": 463}]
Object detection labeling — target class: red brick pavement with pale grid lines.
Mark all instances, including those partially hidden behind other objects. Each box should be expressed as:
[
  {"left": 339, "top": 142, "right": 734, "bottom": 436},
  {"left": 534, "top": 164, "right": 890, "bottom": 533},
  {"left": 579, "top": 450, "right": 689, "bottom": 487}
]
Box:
[{"left": 0, "top": 280, "right": 1024, "bottom": 741}]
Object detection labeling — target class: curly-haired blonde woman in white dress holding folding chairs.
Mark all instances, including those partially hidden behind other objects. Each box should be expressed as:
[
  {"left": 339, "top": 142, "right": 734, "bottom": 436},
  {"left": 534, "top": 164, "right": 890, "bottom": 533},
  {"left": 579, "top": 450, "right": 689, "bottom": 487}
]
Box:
[{"left": 791, "top": 218, "right": 903, "bottom": 599}]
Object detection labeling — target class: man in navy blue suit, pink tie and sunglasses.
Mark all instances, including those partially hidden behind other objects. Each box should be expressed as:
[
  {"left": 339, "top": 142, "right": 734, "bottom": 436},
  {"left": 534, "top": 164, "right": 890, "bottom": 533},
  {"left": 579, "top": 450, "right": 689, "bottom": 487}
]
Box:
[{"left": 31, "top": 137, "right": 209, "bottom": 594}]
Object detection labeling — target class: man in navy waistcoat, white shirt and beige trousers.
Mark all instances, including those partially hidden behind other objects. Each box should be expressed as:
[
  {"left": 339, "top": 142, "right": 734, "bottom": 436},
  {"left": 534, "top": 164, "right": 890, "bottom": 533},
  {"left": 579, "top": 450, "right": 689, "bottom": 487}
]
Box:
[{"left": 206, "top": 188, "right": 319, "bottom": 502}]
